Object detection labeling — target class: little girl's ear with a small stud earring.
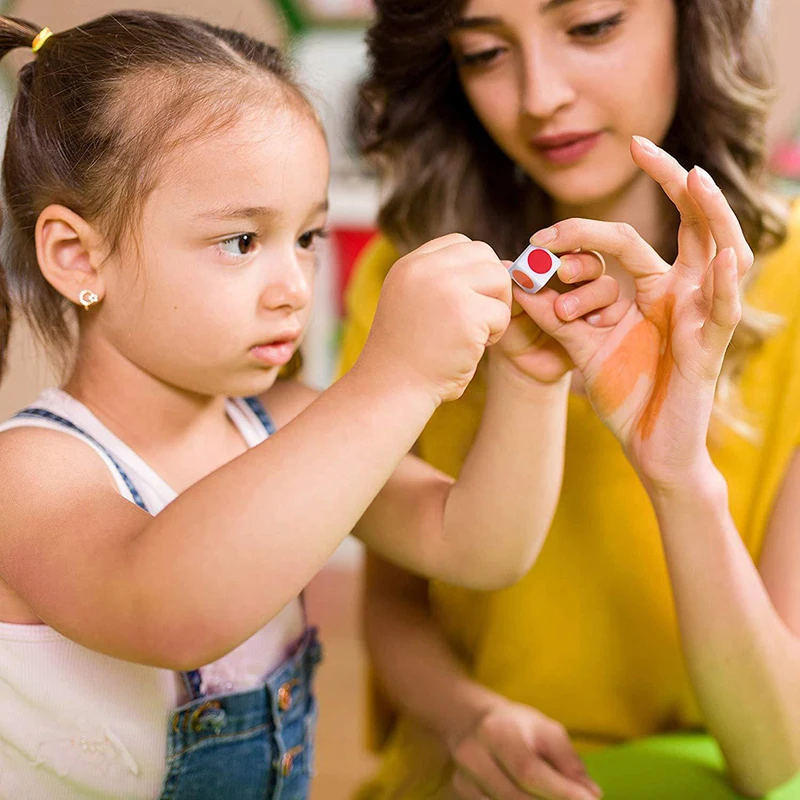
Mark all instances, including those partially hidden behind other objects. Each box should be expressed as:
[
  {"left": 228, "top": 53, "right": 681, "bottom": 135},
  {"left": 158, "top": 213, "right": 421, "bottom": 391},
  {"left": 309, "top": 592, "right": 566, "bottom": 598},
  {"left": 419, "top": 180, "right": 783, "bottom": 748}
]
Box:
[{"left": 36, "top": 205, "right": 106, "bottom": 304}]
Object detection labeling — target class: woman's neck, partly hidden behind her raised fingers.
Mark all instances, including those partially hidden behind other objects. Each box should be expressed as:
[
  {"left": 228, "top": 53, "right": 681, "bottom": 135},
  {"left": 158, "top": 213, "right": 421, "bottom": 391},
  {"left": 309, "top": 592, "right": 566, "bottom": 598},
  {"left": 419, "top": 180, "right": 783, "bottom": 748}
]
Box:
[{"left": 554, "top": 173, "right": 677, "bottom": 261}]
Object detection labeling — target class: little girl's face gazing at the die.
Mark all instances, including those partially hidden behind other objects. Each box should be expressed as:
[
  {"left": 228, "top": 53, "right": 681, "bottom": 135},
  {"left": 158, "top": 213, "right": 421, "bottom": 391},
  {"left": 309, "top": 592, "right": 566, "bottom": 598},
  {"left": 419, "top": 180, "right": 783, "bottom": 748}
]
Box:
[{"left": 97, "top": 106, "right": 329, "bottom": 395}]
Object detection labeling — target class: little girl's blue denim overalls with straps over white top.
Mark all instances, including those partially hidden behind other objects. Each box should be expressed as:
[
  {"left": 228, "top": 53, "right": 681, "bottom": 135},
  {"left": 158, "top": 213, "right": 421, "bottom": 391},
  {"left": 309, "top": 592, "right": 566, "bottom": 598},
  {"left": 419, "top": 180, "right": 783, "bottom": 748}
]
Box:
[{"left": 17, "top": 398, "right": 322, "bottom": 800}]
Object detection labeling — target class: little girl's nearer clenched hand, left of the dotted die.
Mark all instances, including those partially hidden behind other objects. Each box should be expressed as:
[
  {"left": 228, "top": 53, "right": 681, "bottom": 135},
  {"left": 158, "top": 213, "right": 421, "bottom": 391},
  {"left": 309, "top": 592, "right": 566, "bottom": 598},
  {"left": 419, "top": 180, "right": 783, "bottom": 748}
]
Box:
[{"left": 359, "top": 234, "right": 512, "bottom": 404}]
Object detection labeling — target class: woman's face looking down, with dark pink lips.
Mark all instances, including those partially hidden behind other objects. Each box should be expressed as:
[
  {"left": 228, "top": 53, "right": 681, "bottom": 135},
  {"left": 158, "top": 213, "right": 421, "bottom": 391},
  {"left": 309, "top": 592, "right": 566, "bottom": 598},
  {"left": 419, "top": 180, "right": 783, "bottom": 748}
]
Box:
[{"left": 451, "top": 0, "right": 678, "bottom": 206}]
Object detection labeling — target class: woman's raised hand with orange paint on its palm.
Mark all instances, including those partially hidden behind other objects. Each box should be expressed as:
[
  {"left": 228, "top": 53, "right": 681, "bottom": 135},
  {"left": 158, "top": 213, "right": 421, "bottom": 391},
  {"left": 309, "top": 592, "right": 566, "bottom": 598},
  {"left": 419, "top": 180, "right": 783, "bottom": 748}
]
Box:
[{"left": 519, "top": 140, "right": 753, "bottom": 487}]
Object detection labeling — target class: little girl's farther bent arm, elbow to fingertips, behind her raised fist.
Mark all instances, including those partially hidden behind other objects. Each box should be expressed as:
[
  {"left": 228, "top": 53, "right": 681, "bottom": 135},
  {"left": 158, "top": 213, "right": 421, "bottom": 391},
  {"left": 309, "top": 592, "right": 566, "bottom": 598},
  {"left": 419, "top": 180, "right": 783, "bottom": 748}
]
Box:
[{"left": 355, "top": 244, "right": 619, "bottom": 589}]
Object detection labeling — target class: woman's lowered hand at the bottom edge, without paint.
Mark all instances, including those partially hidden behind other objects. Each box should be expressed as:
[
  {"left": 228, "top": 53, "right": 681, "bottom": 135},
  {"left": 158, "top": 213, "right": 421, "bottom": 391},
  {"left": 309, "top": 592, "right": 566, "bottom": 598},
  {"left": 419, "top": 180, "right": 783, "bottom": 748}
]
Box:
[{"left": 449, "top": 697, "right": 602, "bottom": 800}]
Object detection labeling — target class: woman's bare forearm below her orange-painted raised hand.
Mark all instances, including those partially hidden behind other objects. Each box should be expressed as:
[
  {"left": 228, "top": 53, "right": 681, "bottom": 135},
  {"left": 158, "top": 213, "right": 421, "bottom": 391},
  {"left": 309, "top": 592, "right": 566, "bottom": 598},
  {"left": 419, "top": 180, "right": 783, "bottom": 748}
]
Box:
[{"left": 652, "top": 459, "right": 800, "bottom": 795}]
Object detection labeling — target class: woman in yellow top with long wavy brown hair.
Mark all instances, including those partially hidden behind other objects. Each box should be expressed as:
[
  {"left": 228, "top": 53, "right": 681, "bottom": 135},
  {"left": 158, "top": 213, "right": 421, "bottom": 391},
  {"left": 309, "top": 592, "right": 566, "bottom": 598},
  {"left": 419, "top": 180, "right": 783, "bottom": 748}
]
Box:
[{"left": 344, "top": 0, "right": 800, "bottom": 800}]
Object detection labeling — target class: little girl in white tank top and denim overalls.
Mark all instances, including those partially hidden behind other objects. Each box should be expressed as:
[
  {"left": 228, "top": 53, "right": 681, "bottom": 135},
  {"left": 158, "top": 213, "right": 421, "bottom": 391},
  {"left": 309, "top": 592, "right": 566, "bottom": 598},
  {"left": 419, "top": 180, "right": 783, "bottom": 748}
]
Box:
[{"left": 0, "top": 7, "right": 616, "bottom": 800}]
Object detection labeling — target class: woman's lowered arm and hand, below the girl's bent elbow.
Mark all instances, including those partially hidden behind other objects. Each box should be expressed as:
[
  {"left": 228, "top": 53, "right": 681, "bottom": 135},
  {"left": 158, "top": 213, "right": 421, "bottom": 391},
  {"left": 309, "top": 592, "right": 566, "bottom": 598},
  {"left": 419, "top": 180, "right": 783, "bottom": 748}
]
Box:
[{"left": 364, "top": 556, "right": 600, "bottom": 800}]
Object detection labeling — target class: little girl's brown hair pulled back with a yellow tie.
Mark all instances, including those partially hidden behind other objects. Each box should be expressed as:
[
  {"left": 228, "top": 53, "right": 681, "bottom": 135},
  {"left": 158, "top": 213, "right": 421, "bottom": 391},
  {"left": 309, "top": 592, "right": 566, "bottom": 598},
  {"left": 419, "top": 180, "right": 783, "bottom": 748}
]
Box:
[{"left": 0, "top": 11, "right": 313, "bottom": 378}]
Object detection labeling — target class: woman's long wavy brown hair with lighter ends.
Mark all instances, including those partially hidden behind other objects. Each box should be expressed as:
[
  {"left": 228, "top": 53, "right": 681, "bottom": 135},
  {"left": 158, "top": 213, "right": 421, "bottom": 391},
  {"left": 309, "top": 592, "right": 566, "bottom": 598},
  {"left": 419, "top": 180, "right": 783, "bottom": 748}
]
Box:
[{"left": 356, "top": 0, "right": 786, "bottom": 433}]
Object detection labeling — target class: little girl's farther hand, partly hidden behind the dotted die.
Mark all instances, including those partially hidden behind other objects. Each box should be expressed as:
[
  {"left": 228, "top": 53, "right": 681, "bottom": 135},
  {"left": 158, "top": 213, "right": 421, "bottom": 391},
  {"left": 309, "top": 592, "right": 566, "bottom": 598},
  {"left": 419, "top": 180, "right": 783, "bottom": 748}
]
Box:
[{"left": 491, "top": 252, "right": 627, "bottom": 383}]
